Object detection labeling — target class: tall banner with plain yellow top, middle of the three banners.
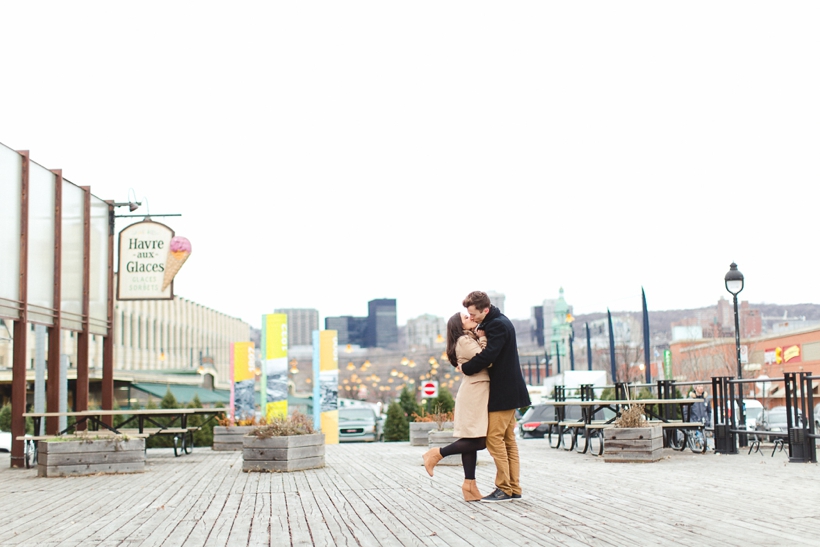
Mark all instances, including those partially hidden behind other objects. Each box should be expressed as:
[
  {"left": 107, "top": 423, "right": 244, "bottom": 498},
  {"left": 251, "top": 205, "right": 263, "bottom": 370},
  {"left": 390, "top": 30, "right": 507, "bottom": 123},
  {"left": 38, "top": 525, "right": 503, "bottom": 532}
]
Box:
[{"left": 261, "top": 313, "right": 288, "bottom": 418}]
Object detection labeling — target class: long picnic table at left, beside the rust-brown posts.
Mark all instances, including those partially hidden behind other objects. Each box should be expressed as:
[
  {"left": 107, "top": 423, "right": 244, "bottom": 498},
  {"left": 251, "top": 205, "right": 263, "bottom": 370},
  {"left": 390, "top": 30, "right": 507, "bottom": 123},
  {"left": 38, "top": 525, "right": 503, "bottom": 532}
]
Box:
[{"left": 17, "top": 408, "right": 225, "bottom": 467}]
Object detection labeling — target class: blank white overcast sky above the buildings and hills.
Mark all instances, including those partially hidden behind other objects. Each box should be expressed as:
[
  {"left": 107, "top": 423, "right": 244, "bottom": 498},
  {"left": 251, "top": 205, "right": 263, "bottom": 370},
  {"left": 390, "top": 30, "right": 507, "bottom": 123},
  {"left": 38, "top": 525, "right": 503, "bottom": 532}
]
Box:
[{"left": 0, "top": 1, "right": 820, "bottom": 326}]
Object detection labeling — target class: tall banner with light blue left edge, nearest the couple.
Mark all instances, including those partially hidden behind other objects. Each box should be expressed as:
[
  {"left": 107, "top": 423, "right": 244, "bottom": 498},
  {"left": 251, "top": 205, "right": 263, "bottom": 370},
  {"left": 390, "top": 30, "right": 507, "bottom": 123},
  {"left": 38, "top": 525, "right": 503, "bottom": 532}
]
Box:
[{"left": 313, "top": 330, "right": 339, "bottom": 444}]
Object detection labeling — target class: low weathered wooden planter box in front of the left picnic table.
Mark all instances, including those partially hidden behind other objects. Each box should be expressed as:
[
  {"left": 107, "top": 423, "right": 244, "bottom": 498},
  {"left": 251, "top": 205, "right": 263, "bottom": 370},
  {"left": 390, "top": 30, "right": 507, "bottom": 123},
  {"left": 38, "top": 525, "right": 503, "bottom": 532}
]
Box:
[{"left": 37, "top": 437, "right": 145, "bottom": 477}]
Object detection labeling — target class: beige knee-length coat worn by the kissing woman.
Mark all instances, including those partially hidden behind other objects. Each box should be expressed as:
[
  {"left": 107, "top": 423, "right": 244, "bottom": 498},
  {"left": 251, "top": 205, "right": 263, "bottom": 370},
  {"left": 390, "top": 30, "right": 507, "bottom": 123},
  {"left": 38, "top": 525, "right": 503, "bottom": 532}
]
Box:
[{"left": 453, "top": 334, "right": 490, "bottom": 439}]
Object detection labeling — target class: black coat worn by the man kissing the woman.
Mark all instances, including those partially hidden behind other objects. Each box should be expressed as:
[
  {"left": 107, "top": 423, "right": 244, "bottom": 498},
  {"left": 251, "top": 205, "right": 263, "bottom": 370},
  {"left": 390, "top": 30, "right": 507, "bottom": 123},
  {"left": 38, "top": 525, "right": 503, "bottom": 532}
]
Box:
[{"left": 461, "top": 306, "right": 530, "bottom": 412}]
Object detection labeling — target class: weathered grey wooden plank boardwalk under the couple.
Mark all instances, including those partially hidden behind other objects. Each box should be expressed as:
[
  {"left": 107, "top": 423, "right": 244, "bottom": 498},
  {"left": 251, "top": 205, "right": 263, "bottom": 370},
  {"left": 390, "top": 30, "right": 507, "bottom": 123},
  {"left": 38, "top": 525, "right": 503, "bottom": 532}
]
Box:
[{"left": 0, "top": 439, "right": 820, "bottom": 547}]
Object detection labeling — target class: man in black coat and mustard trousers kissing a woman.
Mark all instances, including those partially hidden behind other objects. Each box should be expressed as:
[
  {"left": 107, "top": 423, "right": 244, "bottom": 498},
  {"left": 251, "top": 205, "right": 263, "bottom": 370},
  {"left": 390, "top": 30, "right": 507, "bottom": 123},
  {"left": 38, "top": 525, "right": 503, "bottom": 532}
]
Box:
[{"left": 458, "top": 291, "right": 530, "bottom": 502}]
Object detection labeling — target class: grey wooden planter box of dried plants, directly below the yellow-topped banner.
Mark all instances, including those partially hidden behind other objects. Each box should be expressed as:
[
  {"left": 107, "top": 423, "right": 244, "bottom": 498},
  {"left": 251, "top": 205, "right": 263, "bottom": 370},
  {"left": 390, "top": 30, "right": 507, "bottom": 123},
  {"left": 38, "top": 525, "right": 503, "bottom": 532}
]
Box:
[{"left": 242, "top": 433, "right": 325, "bottom": 472}]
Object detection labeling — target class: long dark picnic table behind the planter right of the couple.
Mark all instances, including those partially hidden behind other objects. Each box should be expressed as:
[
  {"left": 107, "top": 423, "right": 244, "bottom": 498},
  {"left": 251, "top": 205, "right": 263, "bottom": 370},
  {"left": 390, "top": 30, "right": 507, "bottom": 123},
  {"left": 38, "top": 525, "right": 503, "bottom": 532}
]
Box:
[{"left": 547, "top": 398, "right": 705, "bottom": 456}]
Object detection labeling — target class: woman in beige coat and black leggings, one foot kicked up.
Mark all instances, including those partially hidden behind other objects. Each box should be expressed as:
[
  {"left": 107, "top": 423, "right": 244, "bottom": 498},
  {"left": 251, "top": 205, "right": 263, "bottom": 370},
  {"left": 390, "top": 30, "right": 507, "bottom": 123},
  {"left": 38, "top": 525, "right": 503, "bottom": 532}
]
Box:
[{"left": 424, "top": 313, "right": 492, "bottom": 501}]
